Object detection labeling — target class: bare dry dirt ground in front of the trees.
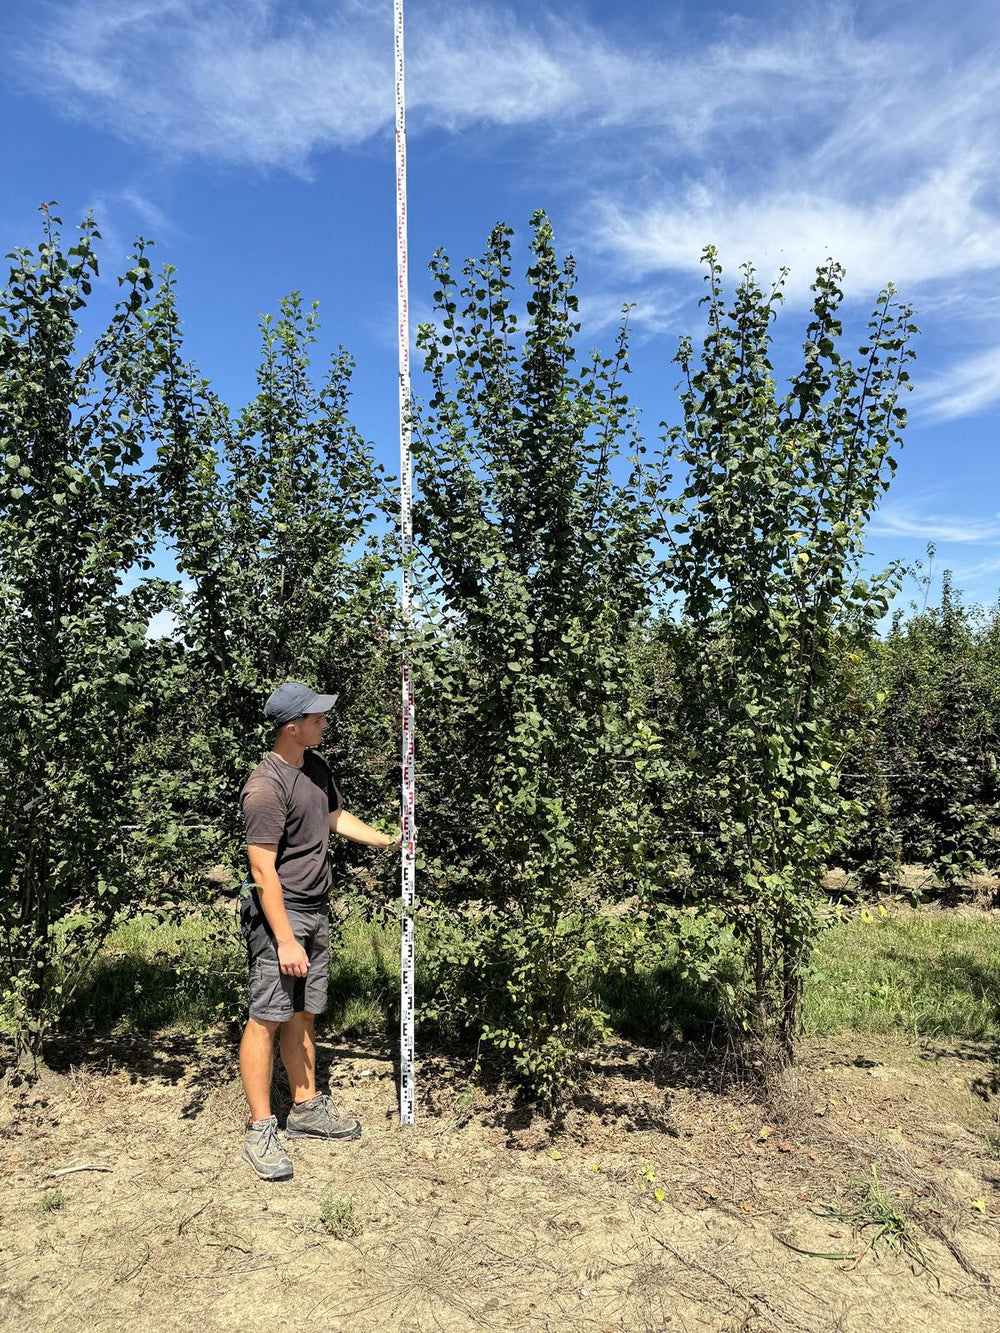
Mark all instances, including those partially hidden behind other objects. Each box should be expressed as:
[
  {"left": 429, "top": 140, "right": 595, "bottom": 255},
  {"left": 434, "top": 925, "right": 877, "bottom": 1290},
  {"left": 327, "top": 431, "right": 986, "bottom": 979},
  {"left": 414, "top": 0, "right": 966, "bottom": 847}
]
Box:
[{"left": 0, "top": 1036, "right": 1000, "bottom": 1333}]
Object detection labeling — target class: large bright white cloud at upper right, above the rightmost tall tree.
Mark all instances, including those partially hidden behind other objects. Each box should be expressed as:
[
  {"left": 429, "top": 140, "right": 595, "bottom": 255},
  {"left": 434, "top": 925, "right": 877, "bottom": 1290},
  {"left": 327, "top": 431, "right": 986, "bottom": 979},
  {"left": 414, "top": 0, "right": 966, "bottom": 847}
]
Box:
[{"left": 593, "top": 5, "right": 1000, "bottom": 305}]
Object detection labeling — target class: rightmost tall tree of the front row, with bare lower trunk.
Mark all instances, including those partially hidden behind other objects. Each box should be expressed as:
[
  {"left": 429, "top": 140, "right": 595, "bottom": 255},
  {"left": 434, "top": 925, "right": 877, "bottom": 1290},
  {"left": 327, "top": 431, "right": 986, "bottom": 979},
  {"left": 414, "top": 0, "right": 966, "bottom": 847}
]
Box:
[{"left": 663, "top": 248, "right": 915, "bottom": 1058}]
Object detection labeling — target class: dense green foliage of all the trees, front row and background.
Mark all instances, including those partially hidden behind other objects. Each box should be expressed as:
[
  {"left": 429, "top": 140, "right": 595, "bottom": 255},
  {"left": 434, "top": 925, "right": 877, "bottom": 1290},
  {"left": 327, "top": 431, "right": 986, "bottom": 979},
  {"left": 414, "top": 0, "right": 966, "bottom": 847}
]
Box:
[{"left": 0, "top": 205, "right": 1000, "bottom": 1102}]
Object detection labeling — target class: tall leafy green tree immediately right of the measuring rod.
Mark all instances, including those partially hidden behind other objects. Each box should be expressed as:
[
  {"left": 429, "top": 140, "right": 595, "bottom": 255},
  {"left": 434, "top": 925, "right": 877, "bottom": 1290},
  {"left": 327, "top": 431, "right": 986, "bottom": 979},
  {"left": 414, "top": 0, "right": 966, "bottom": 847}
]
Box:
[{"left": 415, "top": 213, "right": 655, "bottom": 1100}]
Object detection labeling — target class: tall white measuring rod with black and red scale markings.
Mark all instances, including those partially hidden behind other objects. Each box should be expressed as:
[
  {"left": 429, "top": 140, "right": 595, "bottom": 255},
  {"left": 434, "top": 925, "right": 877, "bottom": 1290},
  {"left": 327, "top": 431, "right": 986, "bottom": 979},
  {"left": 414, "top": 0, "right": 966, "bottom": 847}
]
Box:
[{"left": 393, "top": 0, "right": 416, "bottom": 1125}]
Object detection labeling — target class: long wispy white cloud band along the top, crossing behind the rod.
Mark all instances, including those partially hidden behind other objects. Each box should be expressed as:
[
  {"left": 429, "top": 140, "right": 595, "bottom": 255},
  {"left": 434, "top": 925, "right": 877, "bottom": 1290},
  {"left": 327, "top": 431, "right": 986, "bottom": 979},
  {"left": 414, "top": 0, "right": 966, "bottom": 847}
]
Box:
[{"left": 20, "top": 0, "right": 970, "bottom": 169}]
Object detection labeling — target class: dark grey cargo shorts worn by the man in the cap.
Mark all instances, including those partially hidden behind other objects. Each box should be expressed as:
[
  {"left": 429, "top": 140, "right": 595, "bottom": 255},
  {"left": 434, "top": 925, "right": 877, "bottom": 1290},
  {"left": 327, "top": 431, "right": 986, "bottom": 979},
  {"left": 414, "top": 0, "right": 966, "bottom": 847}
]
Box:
[{"left": 240, "top": 889, "right": 329, "bottom": 1022}]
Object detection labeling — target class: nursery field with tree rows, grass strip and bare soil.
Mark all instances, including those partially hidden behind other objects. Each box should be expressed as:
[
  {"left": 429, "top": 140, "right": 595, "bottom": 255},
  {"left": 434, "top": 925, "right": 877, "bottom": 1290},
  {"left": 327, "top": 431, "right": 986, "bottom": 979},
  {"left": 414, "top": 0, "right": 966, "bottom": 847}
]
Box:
[{"left": 0, "top": 213, "right": 1000, "bottom": 1333}]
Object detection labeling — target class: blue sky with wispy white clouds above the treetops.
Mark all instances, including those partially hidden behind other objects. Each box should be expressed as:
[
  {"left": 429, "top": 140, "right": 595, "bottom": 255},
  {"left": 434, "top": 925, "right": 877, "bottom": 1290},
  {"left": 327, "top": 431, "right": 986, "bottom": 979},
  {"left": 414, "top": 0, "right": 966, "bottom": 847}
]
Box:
[{"left": 0, "top": 0, "right": 1000, "bottom": 613}]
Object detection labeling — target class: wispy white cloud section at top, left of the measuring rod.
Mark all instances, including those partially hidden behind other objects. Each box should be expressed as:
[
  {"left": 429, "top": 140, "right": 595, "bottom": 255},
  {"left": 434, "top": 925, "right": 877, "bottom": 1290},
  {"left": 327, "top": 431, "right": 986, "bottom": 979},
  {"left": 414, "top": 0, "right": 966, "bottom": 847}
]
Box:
[{"left": 23, "top": 0, "right": 392, "bottom": 171}]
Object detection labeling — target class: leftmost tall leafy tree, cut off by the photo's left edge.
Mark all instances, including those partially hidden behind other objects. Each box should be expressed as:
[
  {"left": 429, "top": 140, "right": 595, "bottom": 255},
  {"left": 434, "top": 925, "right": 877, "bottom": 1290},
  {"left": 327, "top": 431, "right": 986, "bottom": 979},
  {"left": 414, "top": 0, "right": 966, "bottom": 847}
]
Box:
[{"left": 0, "top": 207, "right": 176, "bottom": 1058}]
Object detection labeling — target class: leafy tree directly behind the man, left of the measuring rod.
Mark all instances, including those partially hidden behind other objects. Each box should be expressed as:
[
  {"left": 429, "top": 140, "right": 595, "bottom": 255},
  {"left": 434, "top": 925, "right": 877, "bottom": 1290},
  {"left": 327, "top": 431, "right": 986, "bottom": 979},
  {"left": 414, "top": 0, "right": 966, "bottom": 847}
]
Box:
[{"left": 146, "top": 272, "right": 396, "bottom": 890}]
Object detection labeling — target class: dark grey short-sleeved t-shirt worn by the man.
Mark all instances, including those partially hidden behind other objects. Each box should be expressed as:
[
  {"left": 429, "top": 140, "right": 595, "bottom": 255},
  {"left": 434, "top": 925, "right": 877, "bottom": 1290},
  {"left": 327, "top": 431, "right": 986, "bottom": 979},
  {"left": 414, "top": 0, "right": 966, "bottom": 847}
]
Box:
[{"left": 240, "top": 750, "right": 340, "bottom": 908}]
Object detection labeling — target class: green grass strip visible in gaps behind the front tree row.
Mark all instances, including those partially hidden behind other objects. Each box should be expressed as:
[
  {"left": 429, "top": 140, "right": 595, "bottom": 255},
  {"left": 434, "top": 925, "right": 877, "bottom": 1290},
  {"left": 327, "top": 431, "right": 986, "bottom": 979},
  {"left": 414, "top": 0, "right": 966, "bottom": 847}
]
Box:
[{"left": 15, "top": 910, "right": 1000, "bottom": 1042}]
